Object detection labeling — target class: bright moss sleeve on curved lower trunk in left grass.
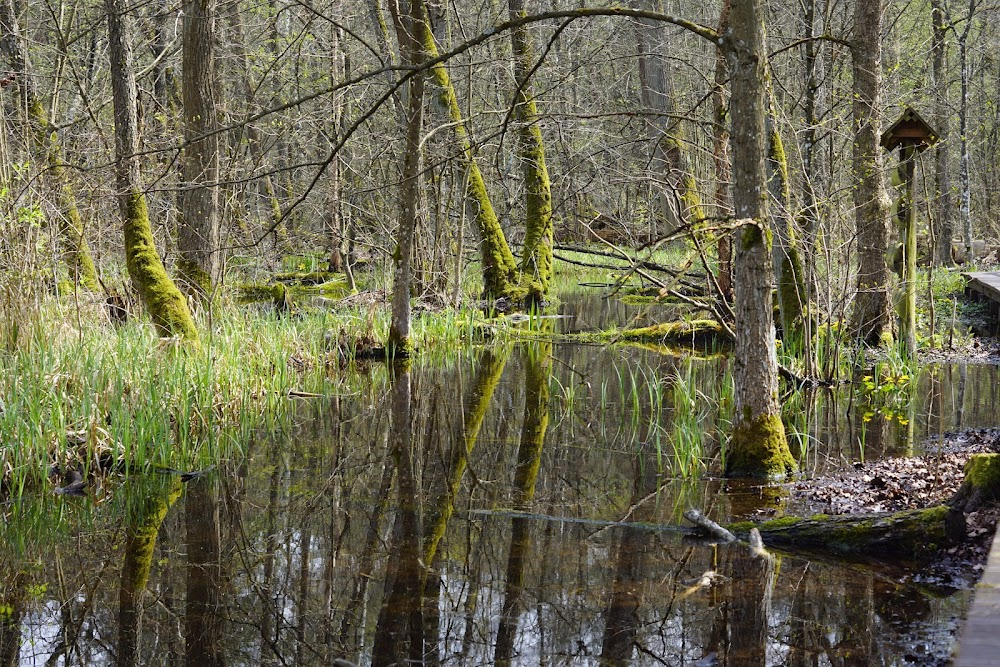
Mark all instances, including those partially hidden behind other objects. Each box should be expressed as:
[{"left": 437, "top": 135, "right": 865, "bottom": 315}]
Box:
[{"left": 125, "top": 192, "right": 198, "bottom": 340}]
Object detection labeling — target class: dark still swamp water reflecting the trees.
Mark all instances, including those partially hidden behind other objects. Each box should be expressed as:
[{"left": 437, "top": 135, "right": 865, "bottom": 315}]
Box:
[{"left": 0, "top": 298, "right": 998, "bottom": 667}]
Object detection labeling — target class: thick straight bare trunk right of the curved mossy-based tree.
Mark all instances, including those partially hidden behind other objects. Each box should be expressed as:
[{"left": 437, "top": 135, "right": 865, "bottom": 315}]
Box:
[{"left": 177, "top": 0, "right": 220, "bottom": 299}]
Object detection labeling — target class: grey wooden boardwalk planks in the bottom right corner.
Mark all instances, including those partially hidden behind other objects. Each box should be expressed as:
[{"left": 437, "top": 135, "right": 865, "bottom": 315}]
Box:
[{"left": 954, "top": 528, "right": 1000, "bottom": 667}]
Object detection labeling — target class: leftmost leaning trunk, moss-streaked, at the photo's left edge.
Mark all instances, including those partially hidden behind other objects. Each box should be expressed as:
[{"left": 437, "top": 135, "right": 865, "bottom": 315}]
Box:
[{"left": 0, "top": 0, "right": 100, "bottom": 290}]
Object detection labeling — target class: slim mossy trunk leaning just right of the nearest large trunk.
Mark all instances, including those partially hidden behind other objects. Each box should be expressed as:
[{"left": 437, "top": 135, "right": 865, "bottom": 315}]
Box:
[{"left": 767, "top": 108, "right": 806, "bottom": 342}]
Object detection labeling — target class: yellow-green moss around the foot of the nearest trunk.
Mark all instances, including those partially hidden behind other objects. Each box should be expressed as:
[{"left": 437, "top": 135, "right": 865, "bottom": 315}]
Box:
[{"left": 726, "top": 414, "right": 797, "bottom": 479}]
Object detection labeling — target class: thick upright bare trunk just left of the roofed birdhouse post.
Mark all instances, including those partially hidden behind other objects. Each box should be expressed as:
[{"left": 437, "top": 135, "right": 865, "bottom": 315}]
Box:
[{"left": 851, "top": 0, "right": 890, "bottom": 345}]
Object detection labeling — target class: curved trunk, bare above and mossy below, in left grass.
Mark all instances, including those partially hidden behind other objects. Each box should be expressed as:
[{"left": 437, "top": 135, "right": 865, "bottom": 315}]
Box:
[{"left": 105, "top": 0, "right": 198, "bottom": 340}]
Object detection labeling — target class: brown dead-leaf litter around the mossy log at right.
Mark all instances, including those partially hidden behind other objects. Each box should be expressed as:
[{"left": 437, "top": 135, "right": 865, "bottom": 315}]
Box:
[{"left": 787, "top": 428, "right": 1000, "bottom": 588}]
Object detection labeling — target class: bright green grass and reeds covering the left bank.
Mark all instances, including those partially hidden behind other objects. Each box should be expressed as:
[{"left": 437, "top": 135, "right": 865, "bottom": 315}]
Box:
[{"left": 0, "top": 298, "right": 486, "bottom": 495}]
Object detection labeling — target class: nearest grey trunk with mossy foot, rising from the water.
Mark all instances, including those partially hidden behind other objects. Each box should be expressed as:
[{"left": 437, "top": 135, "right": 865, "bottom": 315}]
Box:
[{"left": 723, "top": 0, "right": 795, "bottom": 477}]
